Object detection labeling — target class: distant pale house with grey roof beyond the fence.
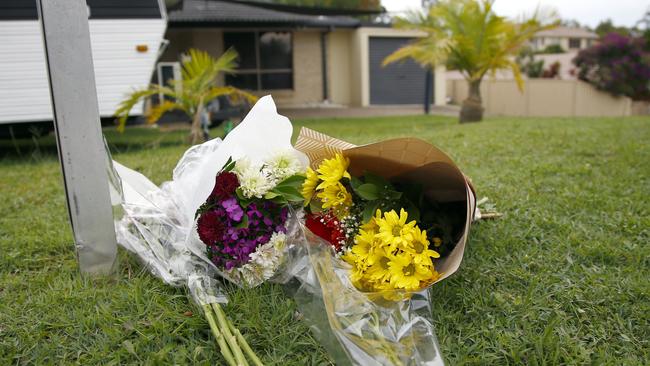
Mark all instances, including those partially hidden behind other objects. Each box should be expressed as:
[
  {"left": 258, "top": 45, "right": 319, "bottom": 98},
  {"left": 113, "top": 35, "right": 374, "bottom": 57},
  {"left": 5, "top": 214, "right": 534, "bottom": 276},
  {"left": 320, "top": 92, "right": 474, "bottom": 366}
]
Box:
[{"left": 530, "top": 27, "right": 598, "bottom": 51}]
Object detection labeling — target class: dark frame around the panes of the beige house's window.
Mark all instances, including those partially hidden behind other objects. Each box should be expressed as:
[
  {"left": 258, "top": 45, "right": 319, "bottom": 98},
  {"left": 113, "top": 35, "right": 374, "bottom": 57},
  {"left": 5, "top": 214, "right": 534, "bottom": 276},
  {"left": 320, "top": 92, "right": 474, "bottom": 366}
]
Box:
[{"left": 222, "top": 29, "right": 296, "bottom": 92}]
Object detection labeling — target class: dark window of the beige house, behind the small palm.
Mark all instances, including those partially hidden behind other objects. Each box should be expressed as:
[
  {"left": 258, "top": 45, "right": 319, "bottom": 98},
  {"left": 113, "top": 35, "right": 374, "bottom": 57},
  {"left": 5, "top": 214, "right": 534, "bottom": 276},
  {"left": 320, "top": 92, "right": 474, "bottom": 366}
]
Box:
[{"left": 223, "top": 32, "right": 293, "bottom": 91}]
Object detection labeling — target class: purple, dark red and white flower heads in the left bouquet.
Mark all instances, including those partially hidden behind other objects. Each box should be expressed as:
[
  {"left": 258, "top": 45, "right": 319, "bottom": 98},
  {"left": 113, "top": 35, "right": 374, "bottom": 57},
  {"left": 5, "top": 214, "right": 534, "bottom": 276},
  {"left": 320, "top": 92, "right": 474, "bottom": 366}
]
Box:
[{"left": 196, "top": 153, "right": 305, "bottom": 286}]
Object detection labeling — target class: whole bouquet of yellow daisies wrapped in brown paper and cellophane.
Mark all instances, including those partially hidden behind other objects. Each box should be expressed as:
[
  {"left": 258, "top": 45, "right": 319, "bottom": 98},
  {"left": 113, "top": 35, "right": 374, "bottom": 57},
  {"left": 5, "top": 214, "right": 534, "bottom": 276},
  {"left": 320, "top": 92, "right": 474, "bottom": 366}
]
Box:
[{"left": 288, "top": 128, "right": 476, "bottom": 365}]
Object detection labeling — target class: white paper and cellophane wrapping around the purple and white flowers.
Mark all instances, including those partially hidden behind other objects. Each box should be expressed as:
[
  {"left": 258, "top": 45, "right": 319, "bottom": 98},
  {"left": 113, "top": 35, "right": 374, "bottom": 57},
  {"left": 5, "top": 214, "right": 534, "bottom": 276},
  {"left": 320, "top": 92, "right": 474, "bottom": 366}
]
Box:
[{"left": 108, "top": 96, "right": 308, "bottom": 305}]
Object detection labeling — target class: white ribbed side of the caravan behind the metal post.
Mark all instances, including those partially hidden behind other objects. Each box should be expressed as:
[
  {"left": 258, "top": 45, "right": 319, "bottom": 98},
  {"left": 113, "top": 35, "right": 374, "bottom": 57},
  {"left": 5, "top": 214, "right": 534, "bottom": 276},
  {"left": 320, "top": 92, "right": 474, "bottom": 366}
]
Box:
[{"left": 0, "top": 0, "right": 167, "bottom": 124}]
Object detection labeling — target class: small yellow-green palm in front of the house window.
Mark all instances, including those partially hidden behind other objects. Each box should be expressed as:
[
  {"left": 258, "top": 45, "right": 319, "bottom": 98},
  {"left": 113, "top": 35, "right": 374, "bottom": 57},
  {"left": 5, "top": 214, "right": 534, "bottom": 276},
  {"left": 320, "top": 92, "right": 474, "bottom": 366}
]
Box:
[{"left": 115, "top": 49, "right": 257, "bottom": 144}]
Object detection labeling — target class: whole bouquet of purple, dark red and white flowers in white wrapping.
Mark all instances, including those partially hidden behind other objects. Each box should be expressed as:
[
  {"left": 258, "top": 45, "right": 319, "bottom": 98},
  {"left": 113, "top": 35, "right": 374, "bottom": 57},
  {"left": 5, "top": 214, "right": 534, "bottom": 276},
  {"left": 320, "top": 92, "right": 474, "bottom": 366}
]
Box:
[{"left": 107, "top": 96, "right": 308, "bottom": 366}]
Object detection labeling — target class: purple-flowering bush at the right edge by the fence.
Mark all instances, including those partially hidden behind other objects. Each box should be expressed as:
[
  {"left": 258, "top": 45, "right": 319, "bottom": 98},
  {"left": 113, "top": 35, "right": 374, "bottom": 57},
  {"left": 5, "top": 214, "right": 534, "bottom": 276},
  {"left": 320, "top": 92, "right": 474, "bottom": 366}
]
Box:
[{"left": 573, "top": 33, "right": 650, "bottom": 100}]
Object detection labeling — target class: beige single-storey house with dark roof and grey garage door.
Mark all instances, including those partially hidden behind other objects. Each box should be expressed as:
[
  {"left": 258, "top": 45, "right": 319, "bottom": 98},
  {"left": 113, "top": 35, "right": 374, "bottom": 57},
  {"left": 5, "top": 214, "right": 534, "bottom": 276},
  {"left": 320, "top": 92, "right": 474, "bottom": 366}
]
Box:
[{"left": 156, "top": 0, "right": 445, "bottom": 107}]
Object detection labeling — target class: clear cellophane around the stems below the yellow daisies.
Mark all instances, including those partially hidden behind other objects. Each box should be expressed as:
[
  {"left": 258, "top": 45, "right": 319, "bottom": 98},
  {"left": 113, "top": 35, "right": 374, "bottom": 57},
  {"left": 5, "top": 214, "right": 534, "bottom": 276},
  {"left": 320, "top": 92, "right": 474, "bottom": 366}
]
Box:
[{"left": 288, "top": 227, "right": 444, "bottom": 366}]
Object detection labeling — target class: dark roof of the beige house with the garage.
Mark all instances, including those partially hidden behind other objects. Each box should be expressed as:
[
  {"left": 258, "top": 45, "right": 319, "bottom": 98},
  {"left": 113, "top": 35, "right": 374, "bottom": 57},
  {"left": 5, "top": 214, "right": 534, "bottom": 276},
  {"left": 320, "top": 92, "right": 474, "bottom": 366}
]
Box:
[{"left": 168, "top": 0, "right": 360, "bottom": 28}]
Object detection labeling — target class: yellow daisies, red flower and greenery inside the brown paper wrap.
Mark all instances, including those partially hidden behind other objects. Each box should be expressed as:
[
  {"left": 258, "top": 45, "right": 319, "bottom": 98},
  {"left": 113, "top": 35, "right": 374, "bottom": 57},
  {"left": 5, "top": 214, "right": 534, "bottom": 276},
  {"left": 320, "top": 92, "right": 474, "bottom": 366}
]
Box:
[{"left": 301, "top": 154, "right": 445, "bottom": 292}]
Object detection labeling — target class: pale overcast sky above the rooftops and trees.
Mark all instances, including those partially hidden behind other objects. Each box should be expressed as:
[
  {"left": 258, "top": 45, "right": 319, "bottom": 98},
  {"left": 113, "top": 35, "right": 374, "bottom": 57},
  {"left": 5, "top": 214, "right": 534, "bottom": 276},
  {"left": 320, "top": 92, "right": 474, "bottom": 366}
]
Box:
[{"left": 381, "top": 0, "right": 650, "bottom": 28}]
